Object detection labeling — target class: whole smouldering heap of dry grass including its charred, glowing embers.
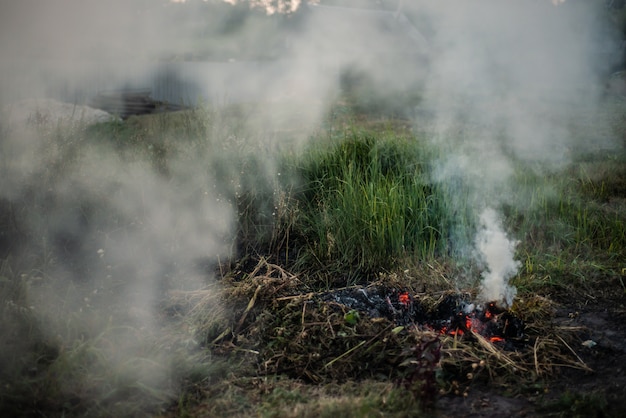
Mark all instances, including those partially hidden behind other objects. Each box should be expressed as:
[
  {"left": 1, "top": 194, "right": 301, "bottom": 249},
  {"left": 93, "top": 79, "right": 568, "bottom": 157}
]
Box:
[{"left": 168, "top": 259, "right": 589, "bottom": 405}]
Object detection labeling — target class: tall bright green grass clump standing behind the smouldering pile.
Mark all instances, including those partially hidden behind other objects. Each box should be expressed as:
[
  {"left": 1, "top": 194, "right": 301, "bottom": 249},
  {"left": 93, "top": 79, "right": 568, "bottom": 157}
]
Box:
[{"left": 270, "top": 130, "right": 470, "bottom": 282}]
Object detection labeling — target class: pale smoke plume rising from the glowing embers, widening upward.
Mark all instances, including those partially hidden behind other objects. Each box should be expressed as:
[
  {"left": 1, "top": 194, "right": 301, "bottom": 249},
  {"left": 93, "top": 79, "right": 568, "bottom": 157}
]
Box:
[{"left": 406, "top": 0, "right": 617, "bottom": 305}]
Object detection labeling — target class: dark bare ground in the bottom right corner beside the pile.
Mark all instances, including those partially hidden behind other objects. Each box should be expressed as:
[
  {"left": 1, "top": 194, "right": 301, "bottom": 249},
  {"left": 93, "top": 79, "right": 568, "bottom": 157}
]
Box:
[{"left": 436, "top": 287, "right": 626, "bottom": 418}]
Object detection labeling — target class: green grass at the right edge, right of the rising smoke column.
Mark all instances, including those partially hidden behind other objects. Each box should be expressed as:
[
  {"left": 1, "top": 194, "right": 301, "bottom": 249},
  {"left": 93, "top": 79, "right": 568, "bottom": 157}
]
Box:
[{"left": 502, "top": 157, "right": 626, "bottom": 291}]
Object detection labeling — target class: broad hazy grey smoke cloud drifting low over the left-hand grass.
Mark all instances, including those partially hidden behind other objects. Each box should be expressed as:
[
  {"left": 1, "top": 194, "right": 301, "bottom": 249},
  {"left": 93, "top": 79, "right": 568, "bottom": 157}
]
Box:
[{"left": 0, "top": 103, "right": 233, "bottom": 405}]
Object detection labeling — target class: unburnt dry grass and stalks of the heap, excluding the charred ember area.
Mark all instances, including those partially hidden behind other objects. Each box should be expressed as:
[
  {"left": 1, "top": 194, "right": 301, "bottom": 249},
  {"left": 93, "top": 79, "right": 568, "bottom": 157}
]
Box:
[{"left": 165, "top": 259, "right": 589, "bottom": 402}]
